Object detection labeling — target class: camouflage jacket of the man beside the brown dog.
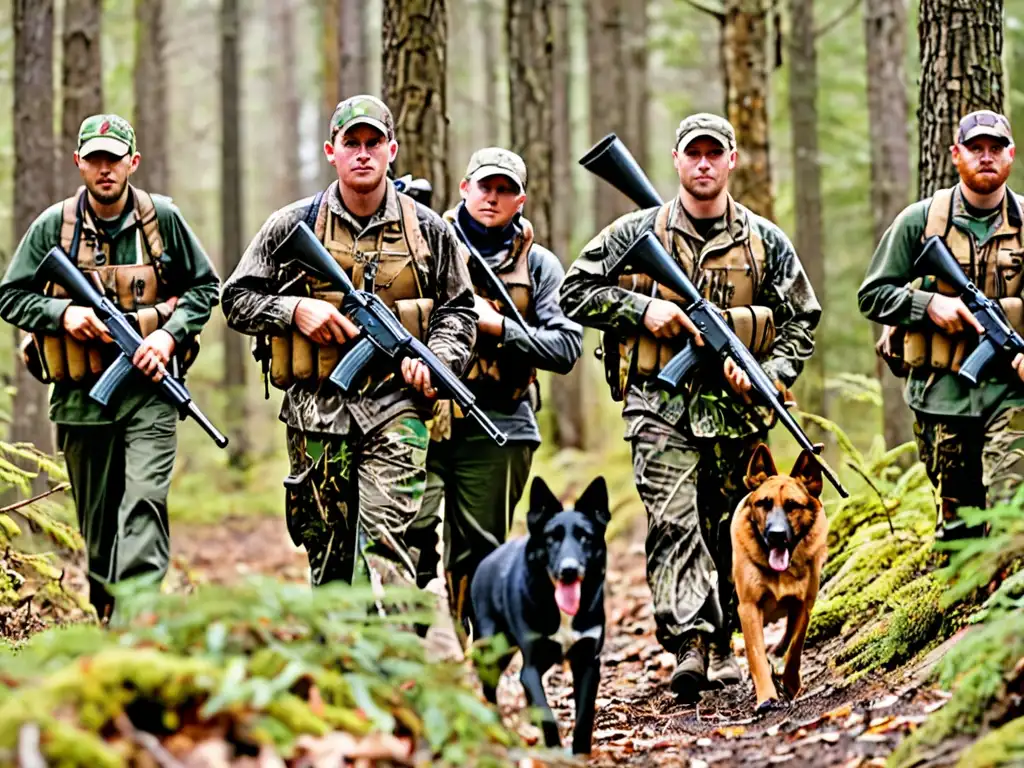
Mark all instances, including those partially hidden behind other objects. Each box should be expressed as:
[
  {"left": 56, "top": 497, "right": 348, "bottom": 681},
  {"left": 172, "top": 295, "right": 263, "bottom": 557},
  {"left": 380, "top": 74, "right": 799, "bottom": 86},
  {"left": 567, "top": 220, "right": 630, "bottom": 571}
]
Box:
[{"left": 559, "top": 198, "right": 821, "bottom": 439}]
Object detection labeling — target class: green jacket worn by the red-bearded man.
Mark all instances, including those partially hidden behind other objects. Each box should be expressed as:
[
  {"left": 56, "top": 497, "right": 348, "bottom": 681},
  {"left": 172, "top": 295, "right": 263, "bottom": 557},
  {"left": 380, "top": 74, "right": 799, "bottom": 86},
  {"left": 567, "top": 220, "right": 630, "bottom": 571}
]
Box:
[{"left": 857, "top": 186, "right": 1024, "bottom": 417}]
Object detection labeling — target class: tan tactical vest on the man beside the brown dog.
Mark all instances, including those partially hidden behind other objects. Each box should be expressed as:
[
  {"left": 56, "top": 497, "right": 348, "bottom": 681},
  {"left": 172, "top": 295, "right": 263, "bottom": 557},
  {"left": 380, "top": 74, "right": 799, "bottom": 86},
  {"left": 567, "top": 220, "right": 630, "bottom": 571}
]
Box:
[{"left": 605, "top": 199, "right": 775, "bottom": 392}]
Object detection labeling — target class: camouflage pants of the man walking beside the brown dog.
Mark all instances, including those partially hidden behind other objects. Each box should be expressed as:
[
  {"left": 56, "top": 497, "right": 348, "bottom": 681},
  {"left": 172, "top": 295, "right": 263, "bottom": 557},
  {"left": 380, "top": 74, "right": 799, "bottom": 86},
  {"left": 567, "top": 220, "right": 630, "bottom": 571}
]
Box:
[{"left": 631, "top": 433, "right": 761, "bottom": 651}]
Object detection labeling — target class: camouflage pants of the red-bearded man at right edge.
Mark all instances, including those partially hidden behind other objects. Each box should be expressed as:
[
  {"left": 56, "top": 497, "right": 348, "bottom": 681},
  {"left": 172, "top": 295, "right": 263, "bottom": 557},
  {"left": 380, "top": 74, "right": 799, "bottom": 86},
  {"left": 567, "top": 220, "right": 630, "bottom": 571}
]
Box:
[{"left": 913, "top": 407, "right": 1024, "bottom": 538}]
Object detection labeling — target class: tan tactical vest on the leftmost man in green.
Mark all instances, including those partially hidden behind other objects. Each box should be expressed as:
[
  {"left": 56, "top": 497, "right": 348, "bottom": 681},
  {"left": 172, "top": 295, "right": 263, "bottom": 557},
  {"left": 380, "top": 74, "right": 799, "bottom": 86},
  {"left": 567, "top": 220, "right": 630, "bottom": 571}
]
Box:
[{"left": 22, "top": 186, "right": 180, "bottom": 383}]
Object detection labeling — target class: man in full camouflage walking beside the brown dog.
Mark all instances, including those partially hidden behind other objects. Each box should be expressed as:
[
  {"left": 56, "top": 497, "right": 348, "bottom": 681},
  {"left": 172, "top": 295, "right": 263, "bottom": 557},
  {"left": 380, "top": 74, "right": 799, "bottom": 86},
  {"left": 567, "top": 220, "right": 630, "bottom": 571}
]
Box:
[{"left": 560, "top": 114, "right": 820, "bottom": 700}]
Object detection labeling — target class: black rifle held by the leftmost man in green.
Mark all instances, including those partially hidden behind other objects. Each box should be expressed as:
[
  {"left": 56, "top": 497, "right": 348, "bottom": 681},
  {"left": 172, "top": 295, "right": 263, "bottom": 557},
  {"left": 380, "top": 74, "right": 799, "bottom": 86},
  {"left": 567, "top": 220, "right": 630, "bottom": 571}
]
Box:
[{"left": 36, "top": 248, "right": 227, "bottom": 447}]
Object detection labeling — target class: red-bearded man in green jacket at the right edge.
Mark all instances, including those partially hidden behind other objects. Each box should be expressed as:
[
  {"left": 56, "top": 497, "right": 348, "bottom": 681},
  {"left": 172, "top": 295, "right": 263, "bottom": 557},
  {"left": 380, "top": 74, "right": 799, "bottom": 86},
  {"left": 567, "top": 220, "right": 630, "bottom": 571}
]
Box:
[{"left": 857, "top": 110, "right": 1024, "bottom": 539}]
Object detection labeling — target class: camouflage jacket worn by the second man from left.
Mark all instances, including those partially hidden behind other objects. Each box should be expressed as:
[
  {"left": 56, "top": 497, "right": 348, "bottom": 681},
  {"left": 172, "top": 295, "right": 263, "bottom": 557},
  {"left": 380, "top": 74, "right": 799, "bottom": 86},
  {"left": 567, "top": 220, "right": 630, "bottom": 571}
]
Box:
[{"left": 221, "top": 180, "right": 476, "bottom": 435}]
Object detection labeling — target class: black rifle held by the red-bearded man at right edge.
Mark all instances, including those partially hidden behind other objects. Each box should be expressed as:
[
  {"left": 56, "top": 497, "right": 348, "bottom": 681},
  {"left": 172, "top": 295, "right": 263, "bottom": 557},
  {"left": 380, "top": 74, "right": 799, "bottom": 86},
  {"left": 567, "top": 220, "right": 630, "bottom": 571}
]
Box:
[{"left": 913, "top": 234, "right": 1024, "bottom": 386}]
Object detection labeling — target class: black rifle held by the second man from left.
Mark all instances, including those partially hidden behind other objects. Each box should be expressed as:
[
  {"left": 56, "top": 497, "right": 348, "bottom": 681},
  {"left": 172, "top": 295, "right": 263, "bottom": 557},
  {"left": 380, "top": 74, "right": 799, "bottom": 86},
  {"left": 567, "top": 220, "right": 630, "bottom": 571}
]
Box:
[{"left": 278, "top": 221, "right": 508, "bottom": 445}]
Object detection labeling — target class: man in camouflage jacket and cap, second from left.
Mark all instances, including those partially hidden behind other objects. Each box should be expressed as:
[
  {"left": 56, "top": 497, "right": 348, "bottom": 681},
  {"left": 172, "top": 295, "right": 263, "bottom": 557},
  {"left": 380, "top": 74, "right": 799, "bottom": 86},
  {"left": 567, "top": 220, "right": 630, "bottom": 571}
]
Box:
[{"left": 222, "top": 96, "right": 476, "bottom": 585}]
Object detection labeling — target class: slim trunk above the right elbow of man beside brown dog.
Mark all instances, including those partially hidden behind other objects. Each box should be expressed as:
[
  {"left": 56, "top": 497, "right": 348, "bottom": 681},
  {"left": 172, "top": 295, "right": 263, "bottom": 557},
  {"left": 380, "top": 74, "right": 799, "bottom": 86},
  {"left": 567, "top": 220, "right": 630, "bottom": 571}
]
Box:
[{"left": 788, "top": 0, "right": 827, "bottom": 430}]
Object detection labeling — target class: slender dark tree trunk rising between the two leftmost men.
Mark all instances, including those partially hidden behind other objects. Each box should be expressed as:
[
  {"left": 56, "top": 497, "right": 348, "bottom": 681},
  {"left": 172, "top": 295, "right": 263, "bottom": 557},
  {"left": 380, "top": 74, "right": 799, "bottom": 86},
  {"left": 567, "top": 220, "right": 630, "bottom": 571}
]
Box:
[{"left": 220, "top": 0, "right": 249, "bottom": 467}]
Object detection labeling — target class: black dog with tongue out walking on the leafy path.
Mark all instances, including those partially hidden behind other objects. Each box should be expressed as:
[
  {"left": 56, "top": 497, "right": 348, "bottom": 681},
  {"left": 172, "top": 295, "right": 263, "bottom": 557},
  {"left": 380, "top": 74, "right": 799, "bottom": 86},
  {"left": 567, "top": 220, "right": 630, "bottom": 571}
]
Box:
[{"left": 470, "top": 477, "right": 610, "bottom": 754}]
